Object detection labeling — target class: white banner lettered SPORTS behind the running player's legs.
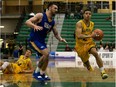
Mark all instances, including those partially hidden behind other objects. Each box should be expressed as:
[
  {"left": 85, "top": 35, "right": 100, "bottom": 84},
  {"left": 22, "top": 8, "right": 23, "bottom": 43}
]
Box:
[{"left": 76, "top": 52, "right": 116, "bottom": 68}]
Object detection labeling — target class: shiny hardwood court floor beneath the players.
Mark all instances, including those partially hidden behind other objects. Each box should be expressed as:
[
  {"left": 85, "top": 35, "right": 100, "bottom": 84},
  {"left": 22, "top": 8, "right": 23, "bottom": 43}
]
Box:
[{"left": 0, "top": 67, "right": 116, "bottom": 87}]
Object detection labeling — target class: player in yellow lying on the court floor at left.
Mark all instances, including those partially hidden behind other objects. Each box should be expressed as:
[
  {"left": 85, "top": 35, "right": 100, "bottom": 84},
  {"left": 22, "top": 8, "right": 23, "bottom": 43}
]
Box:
[{"left": 0, "top": 49, "right": 33, "bottom": 74}]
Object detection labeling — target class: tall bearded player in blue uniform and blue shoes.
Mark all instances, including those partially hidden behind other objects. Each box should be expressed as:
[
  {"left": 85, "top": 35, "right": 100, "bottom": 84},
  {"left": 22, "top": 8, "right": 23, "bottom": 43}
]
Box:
[{"left": 25, "top": 3, "right": 66, "bottom": 80}]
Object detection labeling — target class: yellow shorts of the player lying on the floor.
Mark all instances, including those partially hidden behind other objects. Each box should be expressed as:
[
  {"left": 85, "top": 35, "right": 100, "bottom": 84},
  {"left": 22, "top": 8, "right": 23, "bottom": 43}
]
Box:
[{"left": 3, "top": 63, "right": 22, "bottom": 74}]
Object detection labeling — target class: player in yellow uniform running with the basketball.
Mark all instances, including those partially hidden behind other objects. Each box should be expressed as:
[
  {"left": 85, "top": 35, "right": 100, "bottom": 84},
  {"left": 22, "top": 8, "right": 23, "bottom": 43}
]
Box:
[{"left": 75, "top": 9, "right": 108, "bottom": 79}]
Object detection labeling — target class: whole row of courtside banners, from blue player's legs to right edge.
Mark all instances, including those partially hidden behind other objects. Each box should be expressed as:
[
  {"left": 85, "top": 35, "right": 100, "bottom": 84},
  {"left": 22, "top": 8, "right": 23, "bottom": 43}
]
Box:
[{"left": 48, "top": 52, "right": 116, "bottom": 68}]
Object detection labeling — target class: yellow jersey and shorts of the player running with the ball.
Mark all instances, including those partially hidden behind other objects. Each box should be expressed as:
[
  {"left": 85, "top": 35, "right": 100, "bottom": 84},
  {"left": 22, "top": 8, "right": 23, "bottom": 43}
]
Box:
[{"left": 75, "top": 20, "right": 95, "bottom": 62}]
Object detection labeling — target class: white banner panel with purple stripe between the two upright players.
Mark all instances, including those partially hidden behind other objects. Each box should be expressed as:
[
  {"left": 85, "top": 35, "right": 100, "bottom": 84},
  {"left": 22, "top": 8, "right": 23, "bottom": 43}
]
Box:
[{"left": 55, "top": 52, "right": 76, "bottom": 67}]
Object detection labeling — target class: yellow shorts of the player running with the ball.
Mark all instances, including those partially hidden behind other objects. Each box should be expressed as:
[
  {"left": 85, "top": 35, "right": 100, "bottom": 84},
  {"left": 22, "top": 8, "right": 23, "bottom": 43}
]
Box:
[{"left": 75, "top": 42, "right": 95, "bottom": 62}]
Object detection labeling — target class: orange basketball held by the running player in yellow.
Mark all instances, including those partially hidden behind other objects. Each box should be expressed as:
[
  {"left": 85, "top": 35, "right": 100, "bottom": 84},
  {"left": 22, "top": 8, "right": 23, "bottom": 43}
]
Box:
[{"left": 93, "top": 29, "right": 104, "bottom": 41}]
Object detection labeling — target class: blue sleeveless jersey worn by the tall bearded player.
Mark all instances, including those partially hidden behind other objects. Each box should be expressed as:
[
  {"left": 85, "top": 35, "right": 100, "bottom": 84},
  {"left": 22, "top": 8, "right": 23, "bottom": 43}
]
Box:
[{"left": 29, "top": 13, "right": 55, "bottom": 43}]
